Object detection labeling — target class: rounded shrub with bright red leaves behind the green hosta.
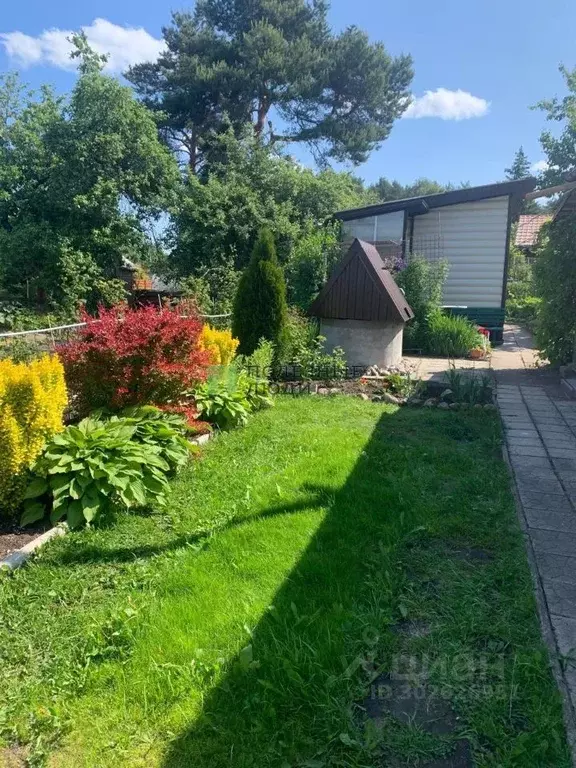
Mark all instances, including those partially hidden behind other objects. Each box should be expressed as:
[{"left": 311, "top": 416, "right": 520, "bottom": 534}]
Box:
[{"left": 59, "top": 305, "right": 209, "bottom": 415}]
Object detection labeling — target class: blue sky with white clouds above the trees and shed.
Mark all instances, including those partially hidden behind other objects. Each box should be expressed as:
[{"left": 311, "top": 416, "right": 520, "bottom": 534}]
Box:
[{"left": 0, "top": 0, "right": 576, "bottom": 184}]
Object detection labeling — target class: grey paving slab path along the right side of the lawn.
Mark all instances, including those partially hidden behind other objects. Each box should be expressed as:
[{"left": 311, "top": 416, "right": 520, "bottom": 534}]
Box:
[{"left": 491, "top": 320, "right": 576, "bottom": 765}]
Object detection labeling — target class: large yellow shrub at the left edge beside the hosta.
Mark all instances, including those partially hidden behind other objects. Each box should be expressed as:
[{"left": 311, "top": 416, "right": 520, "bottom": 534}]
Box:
[{"left": 0, "top": 355, "right": 68, "bottom": 515}]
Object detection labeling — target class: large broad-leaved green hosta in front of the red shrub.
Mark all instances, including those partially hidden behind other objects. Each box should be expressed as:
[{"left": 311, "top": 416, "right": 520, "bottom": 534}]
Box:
[{"left": 22, "top": 409, "right": 196, "bottom": 528}]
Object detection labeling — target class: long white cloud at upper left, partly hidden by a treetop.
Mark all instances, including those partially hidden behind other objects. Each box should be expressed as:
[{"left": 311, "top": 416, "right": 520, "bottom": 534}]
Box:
[{"left": 0, "top": 19, "right": 164, "bottom": 72}]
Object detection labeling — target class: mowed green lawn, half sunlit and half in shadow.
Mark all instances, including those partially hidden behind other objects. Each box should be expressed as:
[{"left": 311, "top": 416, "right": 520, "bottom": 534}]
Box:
[{"left": 0, "top": 397, "right": 570, "bottom": 768}]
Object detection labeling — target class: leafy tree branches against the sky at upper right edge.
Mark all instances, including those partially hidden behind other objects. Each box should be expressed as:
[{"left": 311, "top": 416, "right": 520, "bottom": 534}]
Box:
[{"left": 536, "top": 66, "right": 576, "bottom": 187}]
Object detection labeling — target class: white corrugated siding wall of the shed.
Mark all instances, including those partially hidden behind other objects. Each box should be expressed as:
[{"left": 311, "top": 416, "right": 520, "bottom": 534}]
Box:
[{"left": 413, "top": 197, "right": 508, "bottom": 307}]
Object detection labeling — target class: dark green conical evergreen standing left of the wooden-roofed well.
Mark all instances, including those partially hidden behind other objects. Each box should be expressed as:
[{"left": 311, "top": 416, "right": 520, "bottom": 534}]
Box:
[{"left": 232, "top": 229, "right": 287, "bottom": 358}]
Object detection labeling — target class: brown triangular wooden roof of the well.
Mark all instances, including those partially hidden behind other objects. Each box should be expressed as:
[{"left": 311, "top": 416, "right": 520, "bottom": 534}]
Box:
[{"left": 308, "top": 239, "right": 414, "bottom": 323}]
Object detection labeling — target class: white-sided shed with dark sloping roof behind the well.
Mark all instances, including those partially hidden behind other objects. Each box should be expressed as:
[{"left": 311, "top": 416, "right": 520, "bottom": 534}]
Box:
[{"left": 335, "top": 177, "right": 536, "bottom": 343}]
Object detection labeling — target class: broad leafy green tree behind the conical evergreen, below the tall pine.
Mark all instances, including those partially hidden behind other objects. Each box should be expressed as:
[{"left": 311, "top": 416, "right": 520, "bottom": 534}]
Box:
[{"left": 165, "top": 130, "right": 366, "bottom": 277}]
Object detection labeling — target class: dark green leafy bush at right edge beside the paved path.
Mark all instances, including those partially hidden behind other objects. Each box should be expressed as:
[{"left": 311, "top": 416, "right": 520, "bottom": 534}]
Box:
[{"left": 534, "top": 216, "right": 576, "bottom": 365}]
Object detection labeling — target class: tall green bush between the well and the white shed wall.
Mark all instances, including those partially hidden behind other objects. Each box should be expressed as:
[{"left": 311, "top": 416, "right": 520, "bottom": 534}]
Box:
[{"left": 396, "top": 254, "right": 448, "bottom": 352}]
